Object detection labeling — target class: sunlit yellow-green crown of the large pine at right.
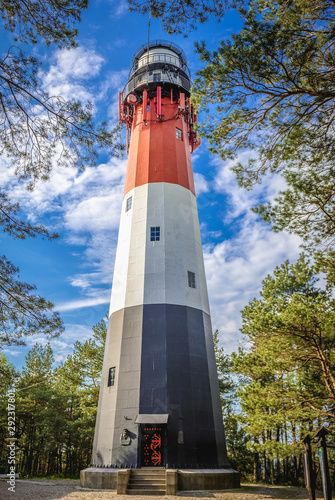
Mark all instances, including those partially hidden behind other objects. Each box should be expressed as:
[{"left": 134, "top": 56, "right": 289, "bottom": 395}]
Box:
[{"left": 242, "top": 252, "right": 335, "bottom": 421}]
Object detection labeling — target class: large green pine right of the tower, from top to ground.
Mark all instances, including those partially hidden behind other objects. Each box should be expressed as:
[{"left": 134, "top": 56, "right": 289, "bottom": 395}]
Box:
[{"left": 227, "top": 255, "right": 335, "bottom": 484}]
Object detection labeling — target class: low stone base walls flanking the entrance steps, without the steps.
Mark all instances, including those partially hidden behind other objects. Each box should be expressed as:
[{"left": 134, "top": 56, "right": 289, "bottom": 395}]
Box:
[{"left": 80, "top": 467, "right": 240, "bottom": 495}]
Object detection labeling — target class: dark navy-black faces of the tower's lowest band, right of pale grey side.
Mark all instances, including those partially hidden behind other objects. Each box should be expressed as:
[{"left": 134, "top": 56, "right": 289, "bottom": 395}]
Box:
[{"left": 140, "top": 304, "right": 227, "bottom": 468}]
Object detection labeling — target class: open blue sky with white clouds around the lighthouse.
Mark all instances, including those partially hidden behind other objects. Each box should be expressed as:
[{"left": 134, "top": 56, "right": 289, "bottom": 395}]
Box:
[{"left": 0, "top": 0, "right": 300, "bottom": 367}]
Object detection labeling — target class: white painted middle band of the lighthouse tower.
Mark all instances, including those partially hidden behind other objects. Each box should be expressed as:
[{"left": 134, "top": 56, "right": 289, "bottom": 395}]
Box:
[{"left": 110, "top": 182, "right": 210, "bottom": 314}]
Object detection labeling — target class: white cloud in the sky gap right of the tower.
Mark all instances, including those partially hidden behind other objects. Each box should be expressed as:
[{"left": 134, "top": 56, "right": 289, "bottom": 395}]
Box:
[{"left": 204, "top": 153, "right": 301, "bottom": 352}]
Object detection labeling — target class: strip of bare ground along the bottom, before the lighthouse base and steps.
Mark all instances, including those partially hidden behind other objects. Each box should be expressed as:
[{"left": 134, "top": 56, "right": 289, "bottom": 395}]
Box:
[{"left": 0, "top": 479, "right": 323, "bottom": 500}]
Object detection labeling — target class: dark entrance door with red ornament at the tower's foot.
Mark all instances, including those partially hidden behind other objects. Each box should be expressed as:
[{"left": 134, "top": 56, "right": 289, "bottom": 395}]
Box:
[{"left": 141, "top": 424, "right": 166, "bottom": 467}]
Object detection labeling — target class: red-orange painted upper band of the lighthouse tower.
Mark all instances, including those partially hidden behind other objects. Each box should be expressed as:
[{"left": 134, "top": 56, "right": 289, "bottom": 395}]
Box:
[{"left": 124, "top": 93, "right": 200, "bottom": 195}]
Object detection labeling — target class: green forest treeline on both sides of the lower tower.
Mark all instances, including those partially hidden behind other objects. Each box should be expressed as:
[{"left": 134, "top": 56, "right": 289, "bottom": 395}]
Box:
[{"left": 0, "top": 255, "right": 335, "bottom": 486}]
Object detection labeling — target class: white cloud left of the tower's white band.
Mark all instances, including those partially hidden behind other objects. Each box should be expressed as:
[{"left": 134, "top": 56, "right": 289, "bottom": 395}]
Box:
[{"left": 0, "top": 158, "right": 126, "bottom": 300}]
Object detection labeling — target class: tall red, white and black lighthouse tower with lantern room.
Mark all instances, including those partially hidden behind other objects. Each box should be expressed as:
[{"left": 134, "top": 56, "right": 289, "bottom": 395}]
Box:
[{"left": 92, "top": 41, "right": 228, "bottom": 468}]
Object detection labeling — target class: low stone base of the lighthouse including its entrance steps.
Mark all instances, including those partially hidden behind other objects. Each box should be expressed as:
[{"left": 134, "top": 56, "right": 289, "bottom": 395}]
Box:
[{"left": 80, "top": 467, "right": 240, "bottom": 495}]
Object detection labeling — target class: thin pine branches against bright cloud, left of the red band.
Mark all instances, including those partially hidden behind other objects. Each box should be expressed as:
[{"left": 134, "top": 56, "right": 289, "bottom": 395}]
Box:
[{"left": 0, "top": 47, "right": 123, "bottom": 189}]
